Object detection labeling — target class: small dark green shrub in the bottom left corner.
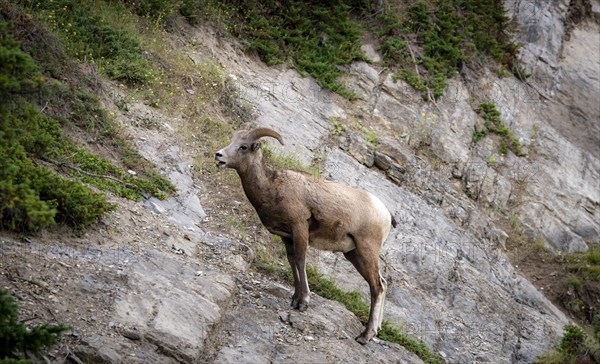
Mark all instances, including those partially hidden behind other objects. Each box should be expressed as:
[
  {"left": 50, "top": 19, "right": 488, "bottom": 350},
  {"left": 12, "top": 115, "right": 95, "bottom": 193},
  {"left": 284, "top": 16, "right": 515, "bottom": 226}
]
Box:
[{"left": 0, "top": 290, "right": 68, "bottom": 363}]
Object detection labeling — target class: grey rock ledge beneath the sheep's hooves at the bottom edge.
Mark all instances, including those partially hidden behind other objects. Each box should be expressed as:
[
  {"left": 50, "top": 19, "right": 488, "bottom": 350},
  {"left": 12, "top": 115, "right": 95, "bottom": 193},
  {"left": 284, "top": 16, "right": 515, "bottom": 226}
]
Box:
[{"left": 214, "top": 295, "right": 422, "bottom": 363}]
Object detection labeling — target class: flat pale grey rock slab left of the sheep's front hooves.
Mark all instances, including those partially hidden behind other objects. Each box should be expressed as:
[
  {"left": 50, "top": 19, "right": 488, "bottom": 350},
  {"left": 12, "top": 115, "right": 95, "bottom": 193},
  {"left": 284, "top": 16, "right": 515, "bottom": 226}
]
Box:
[{"left": 113, "top": 252, "right": 235, "bottom": 362}]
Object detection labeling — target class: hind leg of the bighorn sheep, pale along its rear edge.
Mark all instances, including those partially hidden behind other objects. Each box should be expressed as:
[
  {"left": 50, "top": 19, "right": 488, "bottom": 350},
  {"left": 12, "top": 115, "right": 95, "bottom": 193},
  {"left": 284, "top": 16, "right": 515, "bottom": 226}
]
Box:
[{"left": 344, "top": 249, "right": 387, "bottom": 345}]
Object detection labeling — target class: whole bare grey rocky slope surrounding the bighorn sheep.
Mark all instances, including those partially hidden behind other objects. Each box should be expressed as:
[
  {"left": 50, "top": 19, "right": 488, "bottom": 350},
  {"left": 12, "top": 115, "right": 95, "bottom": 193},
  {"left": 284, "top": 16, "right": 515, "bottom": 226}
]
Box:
[{"left": 0, "top": 0, "right": 600, "bottom": 363}]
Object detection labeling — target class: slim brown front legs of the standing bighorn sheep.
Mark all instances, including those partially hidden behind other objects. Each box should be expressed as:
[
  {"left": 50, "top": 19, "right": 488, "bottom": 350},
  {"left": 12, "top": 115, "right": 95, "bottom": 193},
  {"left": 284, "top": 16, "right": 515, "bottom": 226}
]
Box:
[{"left": 290, "top": 223, "right": 310, "bottom": 311}]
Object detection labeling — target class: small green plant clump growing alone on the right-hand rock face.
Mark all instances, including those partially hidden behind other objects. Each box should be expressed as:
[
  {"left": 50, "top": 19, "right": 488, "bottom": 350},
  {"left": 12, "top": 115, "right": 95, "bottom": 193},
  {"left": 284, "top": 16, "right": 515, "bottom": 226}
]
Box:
[{"left": 472, "top": 102, "right": 527, "bottom": 157}]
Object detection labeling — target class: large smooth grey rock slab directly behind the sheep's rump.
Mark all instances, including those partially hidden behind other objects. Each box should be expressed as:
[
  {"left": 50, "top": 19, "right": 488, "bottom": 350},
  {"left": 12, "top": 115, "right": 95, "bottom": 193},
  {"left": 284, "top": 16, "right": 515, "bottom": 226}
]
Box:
[{"left": 317, "top": 152, "right": 567, "bottom": 362}]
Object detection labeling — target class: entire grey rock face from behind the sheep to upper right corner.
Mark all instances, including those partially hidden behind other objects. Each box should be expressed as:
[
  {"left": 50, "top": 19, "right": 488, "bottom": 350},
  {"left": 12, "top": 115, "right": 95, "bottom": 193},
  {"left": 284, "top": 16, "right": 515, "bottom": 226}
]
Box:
[{"left": 193, "top": 1, "right": 600, "bottom": 363}]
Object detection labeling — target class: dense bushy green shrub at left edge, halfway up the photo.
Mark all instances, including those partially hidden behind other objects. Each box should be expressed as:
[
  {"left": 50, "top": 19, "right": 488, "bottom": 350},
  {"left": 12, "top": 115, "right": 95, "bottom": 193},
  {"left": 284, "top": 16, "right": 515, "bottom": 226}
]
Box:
[{"left": 0, "top": 104, "right": 111, "bottom": 230}]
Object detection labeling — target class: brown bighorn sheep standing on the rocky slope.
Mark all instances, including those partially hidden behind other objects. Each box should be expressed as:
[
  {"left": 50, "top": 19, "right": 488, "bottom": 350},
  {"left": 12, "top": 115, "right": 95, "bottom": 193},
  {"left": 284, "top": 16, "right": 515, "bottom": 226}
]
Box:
[{"left": 215, "top": 128, "right": 395, "bottom": 344}]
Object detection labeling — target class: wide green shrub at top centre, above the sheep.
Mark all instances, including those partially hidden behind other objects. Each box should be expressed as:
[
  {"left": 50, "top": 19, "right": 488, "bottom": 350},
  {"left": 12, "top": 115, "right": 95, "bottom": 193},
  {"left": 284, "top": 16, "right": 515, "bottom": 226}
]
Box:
[{"left": 218, "top": 0, "right": 364, "bottom": 98}]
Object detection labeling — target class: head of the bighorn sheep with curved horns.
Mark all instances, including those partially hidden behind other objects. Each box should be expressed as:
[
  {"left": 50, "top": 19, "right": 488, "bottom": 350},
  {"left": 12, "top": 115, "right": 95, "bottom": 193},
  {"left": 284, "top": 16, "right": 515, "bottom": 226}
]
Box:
[{"left": 215, "top": 128, "right": 283, "bottom": 170}]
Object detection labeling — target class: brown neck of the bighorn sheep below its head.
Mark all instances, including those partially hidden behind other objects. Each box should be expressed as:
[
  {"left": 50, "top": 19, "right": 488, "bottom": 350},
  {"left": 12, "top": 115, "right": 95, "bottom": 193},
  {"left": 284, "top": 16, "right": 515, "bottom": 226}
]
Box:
[{"left": 237, "top": 158, "right": 275, "bottom": 208}]
